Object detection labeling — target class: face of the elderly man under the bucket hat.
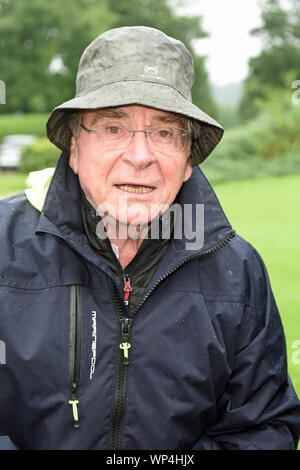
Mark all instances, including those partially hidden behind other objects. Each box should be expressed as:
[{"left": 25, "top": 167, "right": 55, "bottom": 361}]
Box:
[{"left": 69, "top": 105, "right": 192, "bottom": 228}]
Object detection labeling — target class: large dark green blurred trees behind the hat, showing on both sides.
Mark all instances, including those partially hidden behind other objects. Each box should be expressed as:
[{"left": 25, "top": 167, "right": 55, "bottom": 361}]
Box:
[{"left": 0, "top": 0, "right": 216, "bottom": 119}]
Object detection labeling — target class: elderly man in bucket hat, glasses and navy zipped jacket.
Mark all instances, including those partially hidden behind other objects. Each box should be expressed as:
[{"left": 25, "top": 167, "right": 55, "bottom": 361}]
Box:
[{"left": 0, "top": 27, "right": 300, "bottom": 450}]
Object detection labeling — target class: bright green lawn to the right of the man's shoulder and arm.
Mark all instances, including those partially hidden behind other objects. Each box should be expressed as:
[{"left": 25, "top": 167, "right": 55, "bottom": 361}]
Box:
[{"left": 214, "top": 174, "right": 300, "bottom": 397}]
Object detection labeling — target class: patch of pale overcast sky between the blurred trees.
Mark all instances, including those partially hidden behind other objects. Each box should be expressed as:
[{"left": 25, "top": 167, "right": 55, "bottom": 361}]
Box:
[{"left": 177, "top": 0, "right": 261, "bottom": 85}]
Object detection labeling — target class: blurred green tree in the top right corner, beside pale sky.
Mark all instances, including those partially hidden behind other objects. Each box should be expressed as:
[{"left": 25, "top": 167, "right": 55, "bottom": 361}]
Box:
[{"left": 240, "top": 0, "right": 300, "bottom": 120}]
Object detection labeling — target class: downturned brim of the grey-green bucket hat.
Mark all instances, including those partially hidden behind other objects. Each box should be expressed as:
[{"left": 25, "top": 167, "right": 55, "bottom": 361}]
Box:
[{"left": 47, "top": 80, "right": 224, "bottom": 165}]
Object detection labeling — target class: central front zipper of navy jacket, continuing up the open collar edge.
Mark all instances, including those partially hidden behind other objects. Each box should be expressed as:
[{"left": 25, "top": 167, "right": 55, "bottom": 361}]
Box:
[{"left": 108, "top": 231, "right": 235, "bottom": 450}]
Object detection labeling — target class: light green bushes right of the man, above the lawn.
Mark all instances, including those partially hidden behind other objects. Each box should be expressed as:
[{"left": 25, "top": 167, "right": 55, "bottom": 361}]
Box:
[{"left": 201, "top": 90, "right": 300, "bottom": 182}]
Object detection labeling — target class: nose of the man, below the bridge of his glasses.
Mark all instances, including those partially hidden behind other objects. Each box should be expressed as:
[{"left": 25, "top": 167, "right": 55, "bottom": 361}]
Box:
[{"left": 123, "top": 131, "right": 155, "bottom": 169}]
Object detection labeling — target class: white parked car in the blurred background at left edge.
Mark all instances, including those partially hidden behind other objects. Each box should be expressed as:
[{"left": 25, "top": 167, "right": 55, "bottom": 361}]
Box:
[{"left": 0, "top": 134, "right": 37, "bottom": 170}]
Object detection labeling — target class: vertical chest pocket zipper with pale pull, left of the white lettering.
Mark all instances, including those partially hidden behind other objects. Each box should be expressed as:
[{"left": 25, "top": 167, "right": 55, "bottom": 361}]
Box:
[{"left": 69, "top": 285, "right": 82, "bottom": 429}]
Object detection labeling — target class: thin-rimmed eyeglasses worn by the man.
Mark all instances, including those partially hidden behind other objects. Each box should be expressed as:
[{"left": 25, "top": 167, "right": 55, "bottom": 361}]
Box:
[{"left": 80, "top": 123, "right": 190, "bottom": 152}]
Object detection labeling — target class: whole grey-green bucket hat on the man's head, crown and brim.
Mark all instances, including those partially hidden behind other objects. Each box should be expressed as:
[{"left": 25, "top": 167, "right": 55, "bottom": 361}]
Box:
[{"left": 47, "top": 26, "right": 224, "bottom": 165}]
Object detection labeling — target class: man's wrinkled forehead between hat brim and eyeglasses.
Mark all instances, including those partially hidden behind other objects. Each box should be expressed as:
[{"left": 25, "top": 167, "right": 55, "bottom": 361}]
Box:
[{"left": 84, "top": 105, "right": 188, "bottom": 126}]
